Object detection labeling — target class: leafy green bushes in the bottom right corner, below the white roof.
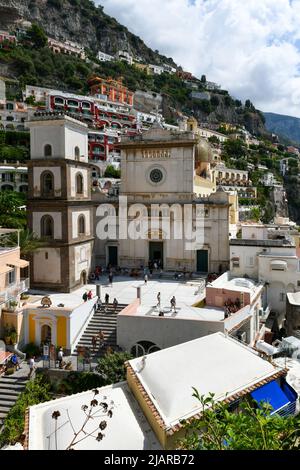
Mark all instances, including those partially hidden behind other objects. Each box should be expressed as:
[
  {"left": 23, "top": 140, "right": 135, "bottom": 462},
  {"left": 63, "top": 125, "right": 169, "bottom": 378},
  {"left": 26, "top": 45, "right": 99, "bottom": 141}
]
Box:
[{"left": 179, "top": 389, "right": 300, "bottom": 450}]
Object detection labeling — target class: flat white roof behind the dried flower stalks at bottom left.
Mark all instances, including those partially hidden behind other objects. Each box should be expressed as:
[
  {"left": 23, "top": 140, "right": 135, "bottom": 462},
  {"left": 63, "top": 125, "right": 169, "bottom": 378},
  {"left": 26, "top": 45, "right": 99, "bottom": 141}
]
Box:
[{"left": 29, "top": 382, "right": 161, "bottom": 450}]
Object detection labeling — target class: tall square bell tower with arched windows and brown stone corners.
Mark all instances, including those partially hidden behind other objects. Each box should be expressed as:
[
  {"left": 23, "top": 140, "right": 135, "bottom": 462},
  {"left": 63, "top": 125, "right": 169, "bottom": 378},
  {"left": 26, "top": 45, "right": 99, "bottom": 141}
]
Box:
[{"left": 27, "top": 112, "right": 94, "bottom": 292}]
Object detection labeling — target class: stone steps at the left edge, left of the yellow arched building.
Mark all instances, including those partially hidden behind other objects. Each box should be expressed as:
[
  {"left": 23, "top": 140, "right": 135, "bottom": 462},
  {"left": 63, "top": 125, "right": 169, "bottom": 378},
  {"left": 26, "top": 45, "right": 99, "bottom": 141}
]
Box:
[{"left": 0, "top": 371, "right": 28, "bottom": 427}]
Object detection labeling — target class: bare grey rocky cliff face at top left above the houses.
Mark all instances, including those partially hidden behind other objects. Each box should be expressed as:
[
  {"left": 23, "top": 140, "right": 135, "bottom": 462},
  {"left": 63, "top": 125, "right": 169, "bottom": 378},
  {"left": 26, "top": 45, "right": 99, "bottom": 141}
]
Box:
[{"left": 0, "top": 0, "right": 175, "bottom": 65}]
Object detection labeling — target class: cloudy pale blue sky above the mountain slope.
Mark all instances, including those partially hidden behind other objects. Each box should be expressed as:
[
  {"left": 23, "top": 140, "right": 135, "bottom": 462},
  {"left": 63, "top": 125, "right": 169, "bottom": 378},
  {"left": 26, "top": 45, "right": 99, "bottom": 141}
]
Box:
[{"left": 95, "top": 0, "right": 300, "bottom": 117}]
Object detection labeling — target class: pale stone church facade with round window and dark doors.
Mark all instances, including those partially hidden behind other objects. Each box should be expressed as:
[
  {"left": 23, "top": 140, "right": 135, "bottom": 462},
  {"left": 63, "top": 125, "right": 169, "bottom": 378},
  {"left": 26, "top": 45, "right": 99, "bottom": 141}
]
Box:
[{"left": 94, "top": 125, "right": 231, "bottom": 273}]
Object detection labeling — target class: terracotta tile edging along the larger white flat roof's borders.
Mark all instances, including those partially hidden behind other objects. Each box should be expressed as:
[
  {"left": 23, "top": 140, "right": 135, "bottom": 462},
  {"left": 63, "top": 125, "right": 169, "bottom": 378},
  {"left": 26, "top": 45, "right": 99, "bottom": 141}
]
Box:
[{"left": 125, "top": 362, "right": 288, "bottom": 436}]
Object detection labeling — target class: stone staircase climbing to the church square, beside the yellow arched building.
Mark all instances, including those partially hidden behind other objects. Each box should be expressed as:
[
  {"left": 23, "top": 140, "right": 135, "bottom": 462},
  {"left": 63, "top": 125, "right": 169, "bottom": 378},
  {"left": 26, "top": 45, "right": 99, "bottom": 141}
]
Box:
[{"left": 72, "top": 304, "right": 127, "bottom": 359}]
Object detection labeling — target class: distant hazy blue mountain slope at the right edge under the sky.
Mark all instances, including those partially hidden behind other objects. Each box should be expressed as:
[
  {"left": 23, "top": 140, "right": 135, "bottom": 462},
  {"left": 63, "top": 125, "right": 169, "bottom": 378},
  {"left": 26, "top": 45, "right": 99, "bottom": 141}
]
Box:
[{"left": 264, "top": 113, "right": 300, "bottom": 145}]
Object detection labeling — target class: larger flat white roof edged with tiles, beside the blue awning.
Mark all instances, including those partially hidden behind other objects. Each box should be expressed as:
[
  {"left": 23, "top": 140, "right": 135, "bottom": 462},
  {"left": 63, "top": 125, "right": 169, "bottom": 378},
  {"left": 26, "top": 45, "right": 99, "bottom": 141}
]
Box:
[{"left": 129, "top": 333, "right": 282, "bottom": 427}]
